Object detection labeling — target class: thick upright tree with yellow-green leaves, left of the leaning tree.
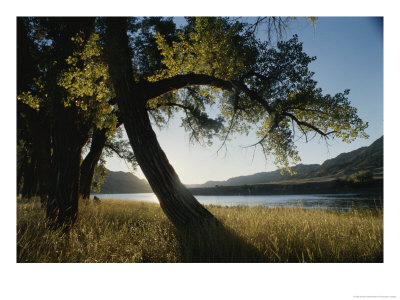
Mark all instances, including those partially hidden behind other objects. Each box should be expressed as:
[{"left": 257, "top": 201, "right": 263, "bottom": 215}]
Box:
[{"left": 17, "top": 18, "right": 118, "bottom": 226}]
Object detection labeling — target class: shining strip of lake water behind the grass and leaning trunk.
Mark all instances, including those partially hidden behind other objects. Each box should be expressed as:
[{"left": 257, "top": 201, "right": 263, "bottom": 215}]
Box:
[{"left": 92, "top": 193, "right": 383, "bottom": 210}]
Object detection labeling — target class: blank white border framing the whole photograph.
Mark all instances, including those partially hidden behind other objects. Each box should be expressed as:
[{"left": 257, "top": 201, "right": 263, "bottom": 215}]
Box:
[{"left": 0, "top": 0, "right": 400, "bottom": 300}]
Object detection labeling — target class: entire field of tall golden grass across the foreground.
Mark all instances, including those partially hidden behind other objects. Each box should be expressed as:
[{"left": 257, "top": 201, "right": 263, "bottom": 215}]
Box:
[{"left": 17, "top": 199, "right": 383, "bottom": 262}]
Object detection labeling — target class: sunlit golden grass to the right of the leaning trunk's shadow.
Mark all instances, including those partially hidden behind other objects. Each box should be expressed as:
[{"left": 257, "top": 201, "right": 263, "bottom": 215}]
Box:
[{"left": 213, "top": 207, "right": 383, "bottom": 262}]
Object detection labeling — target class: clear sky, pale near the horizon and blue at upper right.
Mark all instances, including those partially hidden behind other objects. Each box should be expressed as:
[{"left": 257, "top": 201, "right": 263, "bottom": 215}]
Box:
[{"left": 106, "top": 17, "right": 383, "bottom": 184}]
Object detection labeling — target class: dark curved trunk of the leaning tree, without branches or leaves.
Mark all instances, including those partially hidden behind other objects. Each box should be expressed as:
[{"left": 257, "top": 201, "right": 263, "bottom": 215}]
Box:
[{"left": 105, "top": 18, "right": 215, "bottom": 230}]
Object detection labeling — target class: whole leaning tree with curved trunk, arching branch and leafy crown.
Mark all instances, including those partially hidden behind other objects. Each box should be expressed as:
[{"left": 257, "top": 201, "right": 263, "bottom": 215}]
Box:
[{"left": 104, "top": 18, "right": 367, "bottom": 230}]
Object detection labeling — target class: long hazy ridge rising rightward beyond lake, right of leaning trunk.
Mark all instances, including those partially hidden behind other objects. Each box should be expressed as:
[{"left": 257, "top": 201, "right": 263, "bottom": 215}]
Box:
[{"left": 192, "top": 136, "right": 383, "bottom": 188}]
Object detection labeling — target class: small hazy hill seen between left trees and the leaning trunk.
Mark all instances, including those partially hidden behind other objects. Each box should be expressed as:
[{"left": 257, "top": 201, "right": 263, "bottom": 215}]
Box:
[{"left": 95, "top": 170, "right": 152, "bottom": 194}]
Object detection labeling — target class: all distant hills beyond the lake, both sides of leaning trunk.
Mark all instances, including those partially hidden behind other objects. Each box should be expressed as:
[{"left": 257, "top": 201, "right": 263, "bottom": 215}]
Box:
[{"left": 96, "top": 136, "right": 383, "bottom": 194}]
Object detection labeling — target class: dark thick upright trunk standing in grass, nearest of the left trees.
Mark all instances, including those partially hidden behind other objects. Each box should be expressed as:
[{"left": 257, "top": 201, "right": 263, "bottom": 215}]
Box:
[{"left": 44, "top": 17, "right": 95, "bottom": 230}]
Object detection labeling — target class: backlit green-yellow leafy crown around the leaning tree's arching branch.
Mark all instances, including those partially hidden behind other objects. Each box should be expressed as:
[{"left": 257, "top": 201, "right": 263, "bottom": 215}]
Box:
[{"left": 148, "top": 18, "right": 368, "bottom": 172}]
